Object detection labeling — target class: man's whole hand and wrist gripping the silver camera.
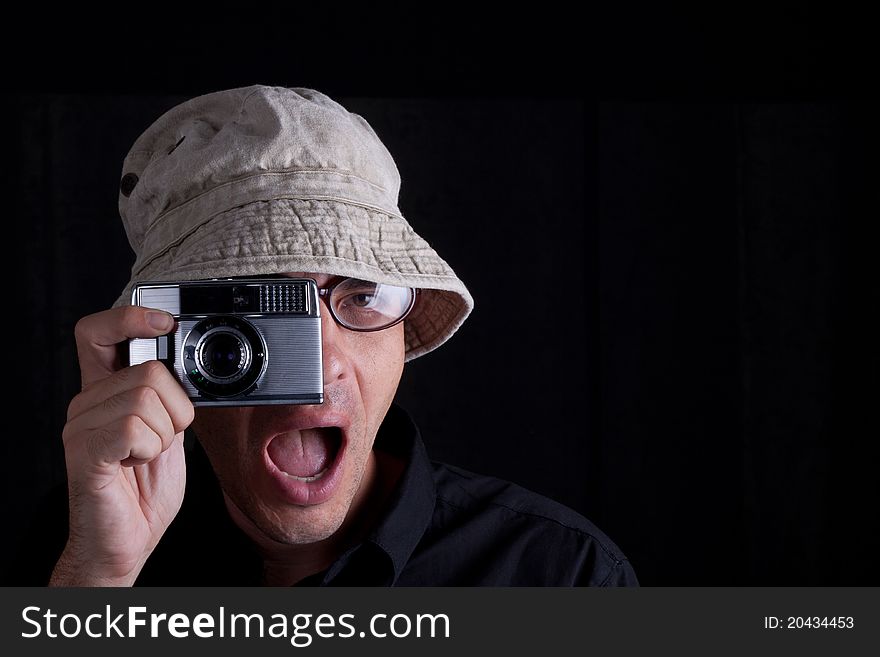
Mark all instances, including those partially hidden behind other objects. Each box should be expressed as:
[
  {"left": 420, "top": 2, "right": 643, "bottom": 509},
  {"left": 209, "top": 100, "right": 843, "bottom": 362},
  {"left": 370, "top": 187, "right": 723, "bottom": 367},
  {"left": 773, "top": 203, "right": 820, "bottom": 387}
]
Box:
[{"left": 50, "top": 306, "right": 194, "bottom": 586}]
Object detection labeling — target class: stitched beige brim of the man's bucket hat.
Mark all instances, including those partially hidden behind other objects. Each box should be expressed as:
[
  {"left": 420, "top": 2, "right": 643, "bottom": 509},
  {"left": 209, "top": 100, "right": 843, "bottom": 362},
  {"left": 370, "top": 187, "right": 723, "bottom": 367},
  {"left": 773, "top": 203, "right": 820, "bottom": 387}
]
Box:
[{"left": 114, "top": 198, "right": 474, "bottom": 361}]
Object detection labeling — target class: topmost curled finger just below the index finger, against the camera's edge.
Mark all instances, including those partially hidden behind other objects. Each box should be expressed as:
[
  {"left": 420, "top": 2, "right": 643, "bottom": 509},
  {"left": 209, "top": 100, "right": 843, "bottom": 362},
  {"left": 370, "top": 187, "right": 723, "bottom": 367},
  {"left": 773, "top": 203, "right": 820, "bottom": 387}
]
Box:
[{"left": 67, "top": 360, "right": 195, "bottom": 433}]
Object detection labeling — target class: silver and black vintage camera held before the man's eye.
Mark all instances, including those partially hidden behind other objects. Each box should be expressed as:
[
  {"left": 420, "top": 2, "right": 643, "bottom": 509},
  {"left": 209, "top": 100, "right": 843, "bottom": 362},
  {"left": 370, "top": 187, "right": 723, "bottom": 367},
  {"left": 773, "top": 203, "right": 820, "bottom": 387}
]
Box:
[{"left": 128, "top": 278, "right": 324, "bottom": 406}]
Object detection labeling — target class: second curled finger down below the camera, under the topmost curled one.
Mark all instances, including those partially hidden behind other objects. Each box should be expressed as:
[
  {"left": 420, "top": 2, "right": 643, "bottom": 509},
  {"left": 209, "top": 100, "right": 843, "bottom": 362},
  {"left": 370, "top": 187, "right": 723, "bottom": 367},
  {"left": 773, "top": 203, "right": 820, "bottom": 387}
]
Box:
[{"left": 63, "top": 386, "right": 176, "bottom": 451}]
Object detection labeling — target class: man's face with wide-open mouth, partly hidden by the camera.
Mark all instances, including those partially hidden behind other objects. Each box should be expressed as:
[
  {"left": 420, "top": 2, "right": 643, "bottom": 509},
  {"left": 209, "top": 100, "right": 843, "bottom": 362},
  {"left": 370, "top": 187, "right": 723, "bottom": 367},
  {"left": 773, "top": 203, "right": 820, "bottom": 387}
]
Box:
[{"left": 193, "top": 273, "right": 404, "bottom": 544}]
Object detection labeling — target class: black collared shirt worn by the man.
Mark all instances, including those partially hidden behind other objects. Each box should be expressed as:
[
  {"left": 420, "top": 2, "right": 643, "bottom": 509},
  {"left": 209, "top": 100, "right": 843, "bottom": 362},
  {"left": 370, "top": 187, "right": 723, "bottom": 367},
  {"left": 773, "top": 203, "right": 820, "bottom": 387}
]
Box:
[{"left": 13, "top": 405, "right": 638, "bottom": 586}]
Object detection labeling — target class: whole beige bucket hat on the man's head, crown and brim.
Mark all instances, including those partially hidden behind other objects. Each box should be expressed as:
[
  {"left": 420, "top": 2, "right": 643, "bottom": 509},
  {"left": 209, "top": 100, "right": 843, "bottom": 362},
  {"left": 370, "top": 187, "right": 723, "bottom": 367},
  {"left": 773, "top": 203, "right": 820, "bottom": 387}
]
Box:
[{"left": 114, "top": 85, "right": 474, "bottom": 360}]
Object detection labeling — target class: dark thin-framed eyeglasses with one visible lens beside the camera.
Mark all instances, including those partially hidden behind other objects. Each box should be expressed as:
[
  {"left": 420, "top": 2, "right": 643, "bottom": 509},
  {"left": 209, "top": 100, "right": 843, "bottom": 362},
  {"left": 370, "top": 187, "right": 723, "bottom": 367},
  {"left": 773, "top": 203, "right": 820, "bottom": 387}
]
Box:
[{"left": 318, "top": 278, "right": 418, "bottom": 331}]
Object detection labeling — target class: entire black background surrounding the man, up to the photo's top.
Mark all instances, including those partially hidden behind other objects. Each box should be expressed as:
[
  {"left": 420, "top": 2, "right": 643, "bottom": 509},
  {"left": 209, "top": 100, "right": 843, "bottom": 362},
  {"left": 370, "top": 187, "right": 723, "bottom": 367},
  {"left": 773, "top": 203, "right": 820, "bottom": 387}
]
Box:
[{"left": 3, "top": 8, "right": 880, "bottom": 585}]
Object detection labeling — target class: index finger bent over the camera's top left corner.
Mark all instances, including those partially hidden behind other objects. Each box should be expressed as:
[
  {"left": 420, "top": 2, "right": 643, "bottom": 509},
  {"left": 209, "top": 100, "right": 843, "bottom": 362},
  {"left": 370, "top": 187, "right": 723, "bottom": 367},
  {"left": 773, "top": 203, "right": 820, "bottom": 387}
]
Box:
[{"left": 74, "top": 306, "right": 174, "bottom": 388}]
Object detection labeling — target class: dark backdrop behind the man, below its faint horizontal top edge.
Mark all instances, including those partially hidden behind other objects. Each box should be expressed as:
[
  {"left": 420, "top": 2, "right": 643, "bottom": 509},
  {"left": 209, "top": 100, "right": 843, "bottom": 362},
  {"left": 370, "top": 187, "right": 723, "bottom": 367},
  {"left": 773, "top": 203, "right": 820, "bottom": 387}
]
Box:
[{"left": 3, "top": 94, "right": 880, "bottom": 585}]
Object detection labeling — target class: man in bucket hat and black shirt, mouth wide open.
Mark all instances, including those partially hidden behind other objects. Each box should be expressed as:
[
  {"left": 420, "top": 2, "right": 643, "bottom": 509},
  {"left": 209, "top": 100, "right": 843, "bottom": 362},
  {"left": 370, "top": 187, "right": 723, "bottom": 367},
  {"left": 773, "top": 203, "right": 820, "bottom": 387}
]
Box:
[{"left": 39, "top": 86, "right": 637, "bottom": 586}]
